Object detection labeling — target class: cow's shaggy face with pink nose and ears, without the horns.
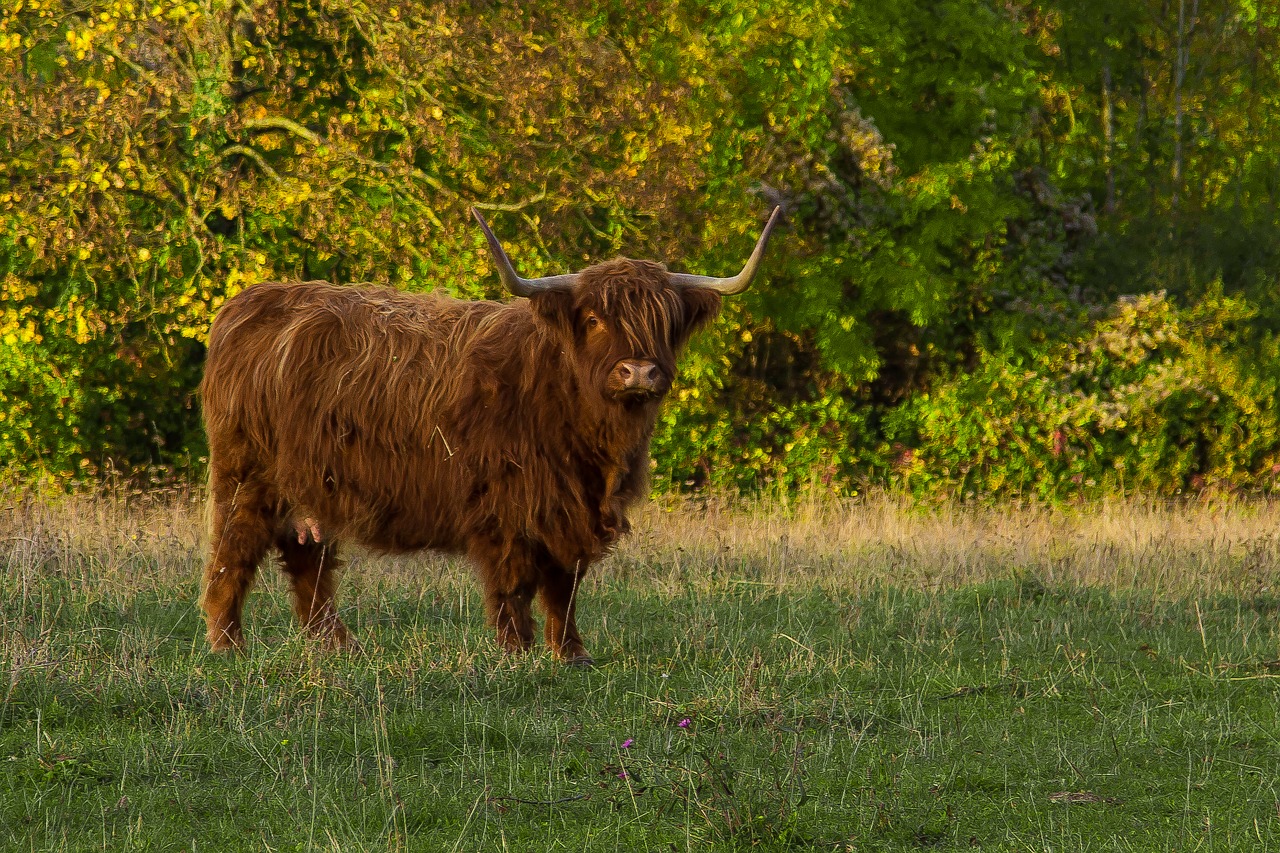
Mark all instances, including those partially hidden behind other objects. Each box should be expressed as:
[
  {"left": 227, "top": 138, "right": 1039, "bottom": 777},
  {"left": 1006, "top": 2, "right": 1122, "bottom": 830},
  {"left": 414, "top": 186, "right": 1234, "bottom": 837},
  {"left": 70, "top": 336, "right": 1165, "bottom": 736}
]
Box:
[{"left": 532, "top": 260, "right": 721, "bottom": 407}]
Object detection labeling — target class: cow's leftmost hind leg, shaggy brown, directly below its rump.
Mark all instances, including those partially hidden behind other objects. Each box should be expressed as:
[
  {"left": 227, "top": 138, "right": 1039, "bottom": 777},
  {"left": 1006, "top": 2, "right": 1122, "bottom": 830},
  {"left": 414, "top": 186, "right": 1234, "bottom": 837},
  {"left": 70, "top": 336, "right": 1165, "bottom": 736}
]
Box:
[{"left": 200, "top": 480, "right": 275, "bottom": 652}]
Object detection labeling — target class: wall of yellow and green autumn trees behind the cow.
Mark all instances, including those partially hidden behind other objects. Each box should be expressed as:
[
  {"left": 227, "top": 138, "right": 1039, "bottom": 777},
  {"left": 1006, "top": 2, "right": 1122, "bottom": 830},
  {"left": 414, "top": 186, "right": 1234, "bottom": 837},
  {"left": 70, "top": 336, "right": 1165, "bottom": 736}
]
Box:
[{"left": 0, "top": 0, "right": 1280, "bottom": 494}]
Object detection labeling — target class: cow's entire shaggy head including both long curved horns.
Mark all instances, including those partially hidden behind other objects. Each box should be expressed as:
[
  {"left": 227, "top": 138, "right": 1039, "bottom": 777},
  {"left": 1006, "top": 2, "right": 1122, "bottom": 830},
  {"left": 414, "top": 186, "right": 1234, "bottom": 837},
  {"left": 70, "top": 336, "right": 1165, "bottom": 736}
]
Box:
[{"left": 471, "top": 207, "right": 782, "bottom": 406}]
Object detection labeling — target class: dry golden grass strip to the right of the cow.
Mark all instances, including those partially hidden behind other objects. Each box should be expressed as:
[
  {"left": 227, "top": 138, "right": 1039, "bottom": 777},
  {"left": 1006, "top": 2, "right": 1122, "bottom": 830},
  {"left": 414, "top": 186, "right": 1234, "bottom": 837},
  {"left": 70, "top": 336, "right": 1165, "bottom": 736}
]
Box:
[{"left": 607, "top": 494, "right": 1280, "bottom": 596}]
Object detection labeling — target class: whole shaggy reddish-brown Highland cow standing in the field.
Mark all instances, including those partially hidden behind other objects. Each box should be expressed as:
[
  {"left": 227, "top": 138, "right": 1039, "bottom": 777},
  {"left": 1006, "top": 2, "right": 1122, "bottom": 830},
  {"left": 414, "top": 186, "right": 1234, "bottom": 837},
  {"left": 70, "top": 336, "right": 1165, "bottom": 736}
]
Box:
[{"left": 201, "top": 204, "right": 780, "bottom": 665}]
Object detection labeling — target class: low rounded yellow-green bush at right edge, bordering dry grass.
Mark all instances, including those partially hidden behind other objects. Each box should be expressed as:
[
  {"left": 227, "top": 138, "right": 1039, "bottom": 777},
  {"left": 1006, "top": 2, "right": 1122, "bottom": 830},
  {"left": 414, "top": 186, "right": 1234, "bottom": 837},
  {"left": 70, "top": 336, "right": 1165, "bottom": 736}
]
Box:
[{"left": 890, "top": 291, "right": 1280, "bottom": 497}]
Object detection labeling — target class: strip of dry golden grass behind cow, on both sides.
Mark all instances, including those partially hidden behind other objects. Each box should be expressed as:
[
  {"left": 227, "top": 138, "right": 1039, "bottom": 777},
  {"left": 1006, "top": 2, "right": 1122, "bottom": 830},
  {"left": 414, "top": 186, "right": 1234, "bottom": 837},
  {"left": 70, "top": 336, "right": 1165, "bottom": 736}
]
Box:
[{"left": 0, "top": 491, "right": 1280, "bottom": 597}]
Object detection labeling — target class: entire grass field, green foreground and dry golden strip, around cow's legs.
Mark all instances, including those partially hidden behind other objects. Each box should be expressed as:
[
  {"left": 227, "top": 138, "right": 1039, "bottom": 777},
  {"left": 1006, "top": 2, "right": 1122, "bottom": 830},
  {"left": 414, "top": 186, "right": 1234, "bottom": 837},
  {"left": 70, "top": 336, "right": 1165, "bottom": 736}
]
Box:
[{"left": 0, "top": 494, "right": 1280, "bottom": 850}]
